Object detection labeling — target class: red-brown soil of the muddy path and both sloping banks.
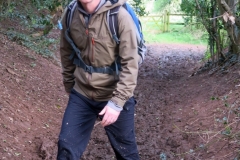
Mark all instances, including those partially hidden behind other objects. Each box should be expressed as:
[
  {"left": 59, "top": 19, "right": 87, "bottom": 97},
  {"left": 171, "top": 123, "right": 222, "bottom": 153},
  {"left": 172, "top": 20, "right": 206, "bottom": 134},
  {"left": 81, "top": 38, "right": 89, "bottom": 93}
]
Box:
[{"left": 0, "top": 30, "right": 240, "bottom": 160}]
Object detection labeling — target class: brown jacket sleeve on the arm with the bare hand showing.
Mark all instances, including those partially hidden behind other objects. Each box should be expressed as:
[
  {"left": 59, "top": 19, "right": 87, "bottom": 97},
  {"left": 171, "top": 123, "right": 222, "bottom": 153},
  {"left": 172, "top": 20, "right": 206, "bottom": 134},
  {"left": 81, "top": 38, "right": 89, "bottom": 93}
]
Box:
[{"left": 110, "top": 7, "right": 139, "bottom": 107}]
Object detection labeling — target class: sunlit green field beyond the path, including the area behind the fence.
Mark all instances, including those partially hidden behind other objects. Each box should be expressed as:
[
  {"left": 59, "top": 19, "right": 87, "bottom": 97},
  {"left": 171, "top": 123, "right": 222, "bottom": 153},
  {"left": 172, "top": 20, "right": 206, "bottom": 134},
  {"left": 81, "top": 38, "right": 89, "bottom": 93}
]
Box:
[{"left": 141, "top": 15, "right": 207, "bottom": 45}]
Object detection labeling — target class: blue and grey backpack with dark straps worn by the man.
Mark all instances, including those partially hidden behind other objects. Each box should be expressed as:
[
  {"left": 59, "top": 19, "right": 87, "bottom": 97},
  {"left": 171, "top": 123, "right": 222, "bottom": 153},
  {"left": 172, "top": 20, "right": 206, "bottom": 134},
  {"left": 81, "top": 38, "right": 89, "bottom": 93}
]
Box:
[{"left": 58, "top": 0, "right": 147, "bottom": 75}]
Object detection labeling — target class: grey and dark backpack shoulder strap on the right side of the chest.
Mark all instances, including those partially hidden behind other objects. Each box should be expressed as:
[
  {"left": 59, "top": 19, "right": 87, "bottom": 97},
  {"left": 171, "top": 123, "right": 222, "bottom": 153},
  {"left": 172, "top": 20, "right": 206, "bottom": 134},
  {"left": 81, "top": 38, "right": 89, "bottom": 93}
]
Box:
[{"left": 107, "top": 6, "right": 121, "bottom": 44}]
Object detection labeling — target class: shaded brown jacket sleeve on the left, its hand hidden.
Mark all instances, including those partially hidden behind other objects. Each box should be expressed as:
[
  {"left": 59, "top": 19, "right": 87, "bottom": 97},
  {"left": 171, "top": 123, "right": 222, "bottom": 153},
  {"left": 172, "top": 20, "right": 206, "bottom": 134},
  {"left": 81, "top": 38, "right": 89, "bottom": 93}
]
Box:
[{"left": 60, "top": 16, "right": 76, "bottom": 93}]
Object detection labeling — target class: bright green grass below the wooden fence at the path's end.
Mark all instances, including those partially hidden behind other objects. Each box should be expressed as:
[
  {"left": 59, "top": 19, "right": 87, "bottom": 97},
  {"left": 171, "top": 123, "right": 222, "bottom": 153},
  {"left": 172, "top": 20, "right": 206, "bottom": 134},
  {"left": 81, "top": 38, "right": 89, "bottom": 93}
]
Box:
[{"left": 143, "top": 23, "right": 207, "bottom": 45}]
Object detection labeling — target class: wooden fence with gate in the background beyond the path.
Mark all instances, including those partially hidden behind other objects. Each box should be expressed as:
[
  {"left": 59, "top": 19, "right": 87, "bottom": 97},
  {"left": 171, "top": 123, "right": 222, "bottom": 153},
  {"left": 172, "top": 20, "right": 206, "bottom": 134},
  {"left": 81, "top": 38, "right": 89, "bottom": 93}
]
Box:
[{"left": 140, "top": 12, "right": 187, "bottom": 32}]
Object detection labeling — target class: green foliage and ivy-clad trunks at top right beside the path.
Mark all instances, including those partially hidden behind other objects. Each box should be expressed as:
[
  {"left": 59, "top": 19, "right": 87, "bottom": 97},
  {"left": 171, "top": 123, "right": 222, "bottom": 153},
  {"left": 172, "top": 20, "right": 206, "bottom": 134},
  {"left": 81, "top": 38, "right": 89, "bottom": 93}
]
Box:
[{"left": 181, "top": 0, "right": 240, "bottom": 67}]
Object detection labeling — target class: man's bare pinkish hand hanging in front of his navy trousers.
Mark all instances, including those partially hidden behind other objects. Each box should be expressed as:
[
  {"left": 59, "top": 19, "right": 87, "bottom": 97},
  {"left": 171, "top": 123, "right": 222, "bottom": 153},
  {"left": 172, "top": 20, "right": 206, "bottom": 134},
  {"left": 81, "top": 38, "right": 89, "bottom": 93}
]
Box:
[{"left": 99, "top": 106, "right": 120, "bottom": 127}]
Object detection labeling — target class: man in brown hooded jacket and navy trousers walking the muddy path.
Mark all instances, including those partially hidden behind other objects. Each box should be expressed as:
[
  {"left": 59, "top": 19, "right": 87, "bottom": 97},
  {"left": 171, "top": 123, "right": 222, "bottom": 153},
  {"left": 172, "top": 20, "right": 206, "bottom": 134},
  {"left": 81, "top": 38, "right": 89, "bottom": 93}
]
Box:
[{"left": 57, "top": 0, "right": 139, "bottom": 160}]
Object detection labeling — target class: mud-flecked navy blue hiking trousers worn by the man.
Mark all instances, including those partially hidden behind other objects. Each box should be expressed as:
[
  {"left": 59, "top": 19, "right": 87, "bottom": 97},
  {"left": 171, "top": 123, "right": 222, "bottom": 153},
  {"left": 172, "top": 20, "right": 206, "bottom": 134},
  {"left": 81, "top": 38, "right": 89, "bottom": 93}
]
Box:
[{"left": 57, "top": 89, "right": 139, "bottom": 160}]
